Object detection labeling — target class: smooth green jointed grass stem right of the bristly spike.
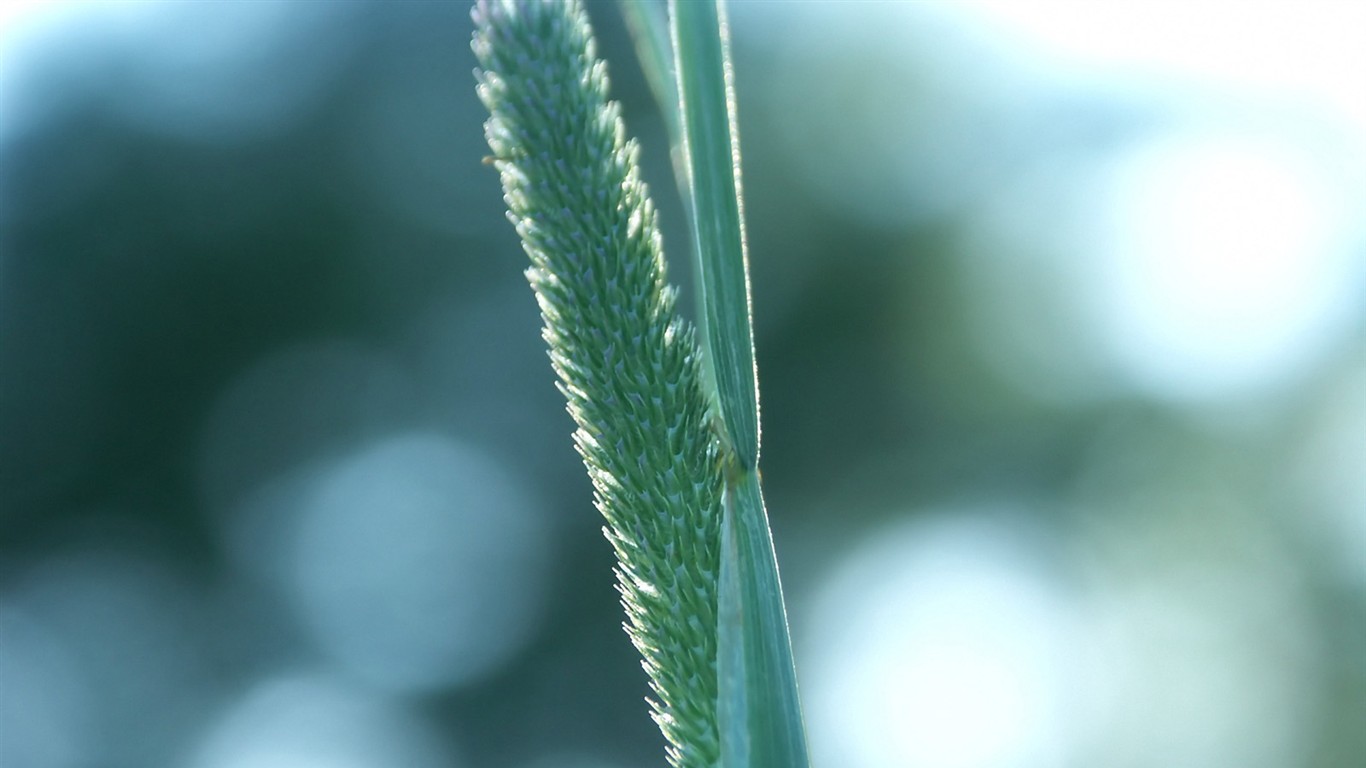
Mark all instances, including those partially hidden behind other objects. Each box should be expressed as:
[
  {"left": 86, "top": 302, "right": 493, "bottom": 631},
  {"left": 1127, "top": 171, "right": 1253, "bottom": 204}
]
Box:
[{"left": 669, "top": 0, "right": 807, "bottom": 768}]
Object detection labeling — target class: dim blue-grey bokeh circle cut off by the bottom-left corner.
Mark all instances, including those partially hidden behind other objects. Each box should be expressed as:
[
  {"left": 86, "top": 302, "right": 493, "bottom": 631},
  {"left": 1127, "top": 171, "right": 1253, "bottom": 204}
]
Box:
[{"left": 0, "top": 543, "right": 213, "bottom": 768}]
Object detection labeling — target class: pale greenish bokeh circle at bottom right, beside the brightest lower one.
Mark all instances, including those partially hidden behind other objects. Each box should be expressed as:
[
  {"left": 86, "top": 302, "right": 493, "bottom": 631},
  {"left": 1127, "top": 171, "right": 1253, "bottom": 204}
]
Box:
[{"left": 1074, "top": 491, "right": 1326, "bottom": 768}]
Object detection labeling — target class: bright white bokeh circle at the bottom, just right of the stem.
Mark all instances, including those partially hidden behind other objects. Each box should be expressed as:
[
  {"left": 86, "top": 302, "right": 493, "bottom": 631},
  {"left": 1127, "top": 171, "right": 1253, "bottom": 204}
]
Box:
[{"left": 798, "top": 514, "right": 1086, "bottom": 768}]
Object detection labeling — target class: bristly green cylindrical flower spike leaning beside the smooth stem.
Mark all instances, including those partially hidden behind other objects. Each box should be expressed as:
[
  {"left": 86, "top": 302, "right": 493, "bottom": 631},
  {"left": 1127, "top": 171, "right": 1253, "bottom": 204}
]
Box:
[{"left": 473, "top": 0, "right": 724, "bottom": 768}]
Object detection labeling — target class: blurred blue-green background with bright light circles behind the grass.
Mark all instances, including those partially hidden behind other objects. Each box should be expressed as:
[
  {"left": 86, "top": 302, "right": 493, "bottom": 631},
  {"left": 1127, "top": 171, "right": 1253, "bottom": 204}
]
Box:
[{"left": 0, "top": 0, "right": 1366, "bottom": 768}]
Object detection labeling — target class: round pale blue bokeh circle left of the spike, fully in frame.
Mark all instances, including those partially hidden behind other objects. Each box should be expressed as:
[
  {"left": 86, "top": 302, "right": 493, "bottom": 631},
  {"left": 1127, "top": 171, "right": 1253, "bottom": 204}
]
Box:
[{"left": 281, "top": 432, "right": 550, "bottom": 691}]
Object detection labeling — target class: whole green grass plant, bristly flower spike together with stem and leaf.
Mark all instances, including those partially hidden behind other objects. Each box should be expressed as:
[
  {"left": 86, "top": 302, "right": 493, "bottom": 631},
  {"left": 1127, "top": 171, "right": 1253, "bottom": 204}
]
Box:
[{"left": 473, "top": 0, "right": 806, "bottom": 768}]
